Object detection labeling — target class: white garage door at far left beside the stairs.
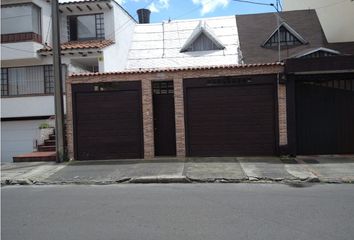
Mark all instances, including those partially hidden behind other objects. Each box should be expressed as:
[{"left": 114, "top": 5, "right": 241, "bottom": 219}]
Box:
[{"left": 1, "top": 120, "right": 45, "bottom": 162}]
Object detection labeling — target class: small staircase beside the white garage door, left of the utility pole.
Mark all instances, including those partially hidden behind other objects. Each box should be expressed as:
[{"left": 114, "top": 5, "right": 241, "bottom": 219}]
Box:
[{"left": 12, "top": 132, "right": 56, "bottom": 162}]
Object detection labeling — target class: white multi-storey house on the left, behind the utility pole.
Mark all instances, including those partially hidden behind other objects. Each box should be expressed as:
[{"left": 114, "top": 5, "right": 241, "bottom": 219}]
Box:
[{"left": 1, "top": 0, "right": 136, "bottom": 162}]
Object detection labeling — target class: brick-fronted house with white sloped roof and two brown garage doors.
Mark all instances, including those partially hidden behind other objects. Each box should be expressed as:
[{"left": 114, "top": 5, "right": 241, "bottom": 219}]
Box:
[{"left": 67, "top": 13, "right": 286, "bottom": 160}]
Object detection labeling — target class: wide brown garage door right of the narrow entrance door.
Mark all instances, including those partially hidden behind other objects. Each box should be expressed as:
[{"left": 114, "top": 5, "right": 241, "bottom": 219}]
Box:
[{"left": 184, "top": 77, "right": 276, "bottom": 156}]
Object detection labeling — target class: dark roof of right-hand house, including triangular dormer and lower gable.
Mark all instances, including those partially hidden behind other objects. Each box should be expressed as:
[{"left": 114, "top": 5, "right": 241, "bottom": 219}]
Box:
[{"left": 236, "top": 10, "right": 354, "bottom": 63}]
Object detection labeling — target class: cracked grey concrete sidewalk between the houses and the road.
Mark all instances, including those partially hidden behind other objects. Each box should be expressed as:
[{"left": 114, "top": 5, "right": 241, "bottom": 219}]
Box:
[{"left": 1, "top": 155, "right": 354, "bottom": 185}]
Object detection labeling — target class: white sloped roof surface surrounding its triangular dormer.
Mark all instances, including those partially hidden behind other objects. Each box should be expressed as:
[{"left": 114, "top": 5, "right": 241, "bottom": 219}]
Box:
[{"left": 126, "top": 16, "right": 239, "bottom": 69}]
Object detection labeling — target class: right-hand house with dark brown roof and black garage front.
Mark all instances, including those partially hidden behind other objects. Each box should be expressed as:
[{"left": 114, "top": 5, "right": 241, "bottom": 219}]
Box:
[{"left": 236, "top": 9, "right": 354, "bottom": 154}]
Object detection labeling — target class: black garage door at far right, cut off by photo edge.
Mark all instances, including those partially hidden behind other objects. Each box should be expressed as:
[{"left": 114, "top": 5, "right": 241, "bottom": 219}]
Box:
[{"left": 296, "top": 76, "right": 354, "bottom": 154}]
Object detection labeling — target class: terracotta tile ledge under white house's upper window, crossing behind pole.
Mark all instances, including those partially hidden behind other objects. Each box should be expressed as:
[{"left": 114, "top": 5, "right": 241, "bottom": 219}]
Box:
[{"left": 39, "top": 40, "right": 113, "bottom": 52}]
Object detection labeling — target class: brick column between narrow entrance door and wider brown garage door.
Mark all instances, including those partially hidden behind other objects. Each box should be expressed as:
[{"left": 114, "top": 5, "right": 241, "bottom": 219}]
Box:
[{"left": 173, "top": 77, "right": 186, "bottom": 157}]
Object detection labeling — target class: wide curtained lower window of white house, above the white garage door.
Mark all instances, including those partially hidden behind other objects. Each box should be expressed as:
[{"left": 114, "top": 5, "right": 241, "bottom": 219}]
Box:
[{"left": 1, "top": 65, "right": 66, "bottom": 96}]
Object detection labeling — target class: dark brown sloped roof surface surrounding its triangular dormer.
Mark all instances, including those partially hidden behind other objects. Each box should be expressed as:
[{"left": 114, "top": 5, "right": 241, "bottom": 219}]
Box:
[{"left": 236, "top": 10, "right": 330, "bottom": 63}]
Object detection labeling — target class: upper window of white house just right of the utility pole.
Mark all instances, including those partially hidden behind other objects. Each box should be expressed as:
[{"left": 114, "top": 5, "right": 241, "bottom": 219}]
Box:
[{"left": 68, "top": 13, "right": 104, "bottom": 41}]
